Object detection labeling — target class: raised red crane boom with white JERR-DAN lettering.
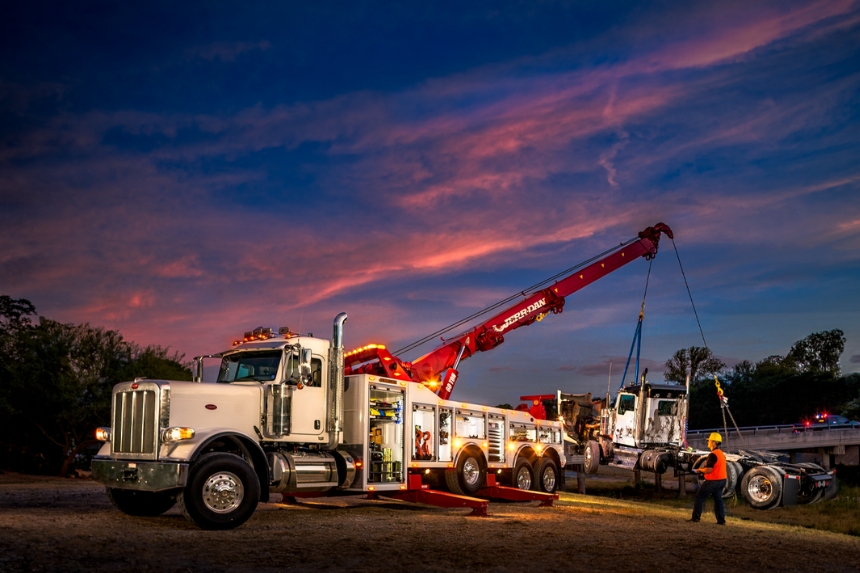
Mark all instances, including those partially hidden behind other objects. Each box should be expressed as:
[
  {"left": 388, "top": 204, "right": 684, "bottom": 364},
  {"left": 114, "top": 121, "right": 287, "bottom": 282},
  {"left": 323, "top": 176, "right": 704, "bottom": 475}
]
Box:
[{"left": 344, "top": 223, "right": 673, "bottom": 400}]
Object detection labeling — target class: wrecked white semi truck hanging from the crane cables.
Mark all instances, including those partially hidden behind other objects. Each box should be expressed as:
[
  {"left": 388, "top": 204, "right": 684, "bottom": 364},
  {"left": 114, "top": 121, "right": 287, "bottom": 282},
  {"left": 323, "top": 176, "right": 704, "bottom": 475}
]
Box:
[{"left": 544, "top": 378, "right": 836, "bottom": 509}]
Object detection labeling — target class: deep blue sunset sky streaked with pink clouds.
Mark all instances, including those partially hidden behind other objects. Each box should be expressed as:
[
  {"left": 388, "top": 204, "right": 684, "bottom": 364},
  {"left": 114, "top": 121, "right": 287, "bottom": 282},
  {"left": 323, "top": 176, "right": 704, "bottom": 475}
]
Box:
[{"left": 0, "top": 0, "right": 860, "bottom": 404}]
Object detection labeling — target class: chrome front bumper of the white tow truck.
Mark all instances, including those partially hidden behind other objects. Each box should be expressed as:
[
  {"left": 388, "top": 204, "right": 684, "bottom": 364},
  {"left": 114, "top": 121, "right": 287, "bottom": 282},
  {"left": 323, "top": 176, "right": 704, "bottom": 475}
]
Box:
[{"left": 92, "top": 458, "right": 188, "bottom": 491}]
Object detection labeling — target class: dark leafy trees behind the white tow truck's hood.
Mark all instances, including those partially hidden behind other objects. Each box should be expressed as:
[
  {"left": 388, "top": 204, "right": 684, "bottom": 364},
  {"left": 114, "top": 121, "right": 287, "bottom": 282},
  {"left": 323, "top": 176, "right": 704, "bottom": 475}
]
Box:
[{"left": 0, "top": 295, "right": 191, "bottom": 475}]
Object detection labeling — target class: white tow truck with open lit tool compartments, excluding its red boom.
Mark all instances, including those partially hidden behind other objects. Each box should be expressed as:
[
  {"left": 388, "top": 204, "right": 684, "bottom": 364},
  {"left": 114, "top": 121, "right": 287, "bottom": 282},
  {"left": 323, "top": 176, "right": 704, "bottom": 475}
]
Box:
[{"left": 92, "top": 313, "right": 566, "bottom": 529}]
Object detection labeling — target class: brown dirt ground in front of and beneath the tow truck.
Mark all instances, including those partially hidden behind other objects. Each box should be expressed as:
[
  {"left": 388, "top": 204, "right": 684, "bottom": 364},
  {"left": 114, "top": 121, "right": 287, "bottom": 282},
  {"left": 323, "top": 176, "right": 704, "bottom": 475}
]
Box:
[{"left": 0, "top": 473, "right": 860, "bottom": 573}]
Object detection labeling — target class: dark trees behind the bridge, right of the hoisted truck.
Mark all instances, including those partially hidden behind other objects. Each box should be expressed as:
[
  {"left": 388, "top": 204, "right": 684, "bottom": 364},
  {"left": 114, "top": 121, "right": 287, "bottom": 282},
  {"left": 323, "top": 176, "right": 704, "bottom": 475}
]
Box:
[{"left": 664, "top": 329, "right": 860, "bottom": 429}]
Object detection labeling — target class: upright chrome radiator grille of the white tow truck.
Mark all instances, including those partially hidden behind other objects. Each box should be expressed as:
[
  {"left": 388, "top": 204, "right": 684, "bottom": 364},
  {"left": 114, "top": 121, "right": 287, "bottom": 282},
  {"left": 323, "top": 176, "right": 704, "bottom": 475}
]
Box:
[{"left": 111, "top": 384, "right": 161, "bottom": 459}]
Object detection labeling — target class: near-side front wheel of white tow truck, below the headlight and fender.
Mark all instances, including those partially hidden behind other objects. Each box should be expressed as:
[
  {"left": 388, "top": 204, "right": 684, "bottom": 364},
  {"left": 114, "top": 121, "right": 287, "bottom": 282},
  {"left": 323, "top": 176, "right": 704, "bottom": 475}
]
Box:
[{"left": 176, "top": 453, "right": 260, "bottom": 529}]
